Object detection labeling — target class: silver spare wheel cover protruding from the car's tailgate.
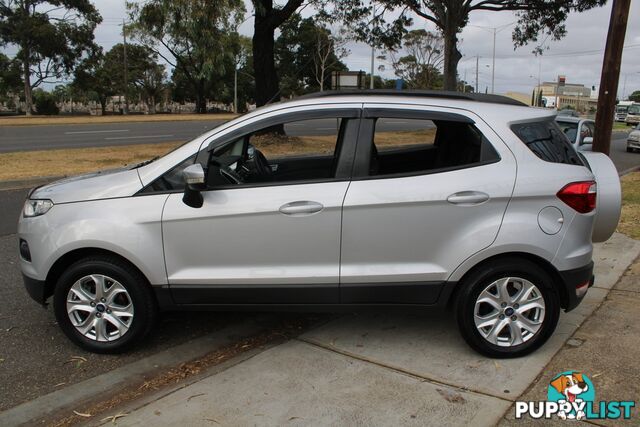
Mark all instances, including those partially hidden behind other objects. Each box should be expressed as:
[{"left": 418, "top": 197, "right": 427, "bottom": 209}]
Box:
[{"left": 582, "top": 152, "right": 622, "bottom": 243}]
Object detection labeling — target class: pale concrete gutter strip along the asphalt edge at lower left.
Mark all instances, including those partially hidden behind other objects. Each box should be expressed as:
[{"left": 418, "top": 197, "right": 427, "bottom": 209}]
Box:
[{"left": 0, "top": 322, "right": 263, "bottom": 426}]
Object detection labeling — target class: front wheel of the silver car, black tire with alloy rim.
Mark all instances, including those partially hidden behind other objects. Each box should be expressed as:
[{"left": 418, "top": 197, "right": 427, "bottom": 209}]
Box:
[{"left": 53, "top": 257, "right": 157, "bottom": 354}]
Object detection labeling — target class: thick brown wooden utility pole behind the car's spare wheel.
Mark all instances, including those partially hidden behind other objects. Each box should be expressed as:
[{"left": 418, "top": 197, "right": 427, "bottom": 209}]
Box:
[{"left": 593, "top": 0, "right": 631, "bottom": 155}]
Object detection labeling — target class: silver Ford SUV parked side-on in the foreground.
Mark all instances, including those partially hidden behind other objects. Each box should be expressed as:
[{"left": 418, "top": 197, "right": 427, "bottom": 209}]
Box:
[{"left": 19, "top": 91, "right": 621, "bottom": 357}]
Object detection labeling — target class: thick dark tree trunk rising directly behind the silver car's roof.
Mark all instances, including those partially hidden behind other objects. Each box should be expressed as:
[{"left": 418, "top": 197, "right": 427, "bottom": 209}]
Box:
[{"left": 253, "top": 21, "right": 280, "bottom": 107}]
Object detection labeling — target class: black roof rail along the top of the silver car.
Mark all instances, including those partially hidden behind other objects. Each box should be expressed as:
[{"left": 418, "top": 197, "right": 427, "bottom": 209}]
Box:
[{"left": 294, "top": 89, "right": 528, "bottom": 107}]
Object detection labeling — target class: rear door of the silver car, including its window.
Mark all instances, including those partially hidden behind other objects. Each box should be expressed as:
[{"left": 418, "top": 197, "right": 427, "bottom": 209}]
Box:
[{"left": 340, "top": 104, "right": 516, "bottom": 304}]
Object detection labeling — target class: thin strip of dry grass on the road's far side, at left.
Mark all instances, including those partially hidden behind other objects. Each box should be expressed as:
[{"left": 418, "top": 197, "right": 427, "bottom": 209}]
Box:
[{"left": 0, "top": 114, "right": 238, "bottom": 126}]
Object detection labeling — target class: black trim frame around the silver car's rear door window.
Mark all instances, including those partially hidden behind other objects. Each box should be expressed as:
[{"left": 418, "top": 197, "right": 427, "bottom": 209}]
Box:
[{"left": 351, "top": 108, "right": 502, "bottom": 181}]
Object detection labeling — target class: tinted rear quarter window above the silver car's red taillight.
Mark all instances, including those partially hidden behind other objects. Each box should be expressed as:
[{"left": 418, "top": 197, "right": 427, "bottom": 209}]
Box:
[{"left": 511, "top": 121, "right": 584, "bottom": 166}]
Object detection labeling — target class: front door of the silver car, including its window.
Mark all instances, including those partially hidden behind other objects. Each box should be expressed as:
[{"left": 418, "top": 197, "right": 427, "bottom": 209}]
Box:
[{"left": 162, "top": 111, "right": 359, "bottom": 305}]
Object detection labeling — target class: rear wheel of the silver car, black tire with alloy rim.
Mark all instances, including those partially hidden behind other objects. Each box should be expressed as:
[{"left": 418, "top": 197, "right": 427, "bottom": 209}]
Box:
[{"left": 455, "top": 257, "right": 560, "bottom": 358}]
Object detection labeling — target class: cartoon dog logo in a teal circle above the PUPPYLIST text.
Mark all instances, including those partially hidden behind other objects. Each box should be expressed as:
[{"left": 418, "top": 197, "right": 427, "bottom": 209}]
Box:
[{"left": 547, "top": 371, "right": 595, "bottom": 420}]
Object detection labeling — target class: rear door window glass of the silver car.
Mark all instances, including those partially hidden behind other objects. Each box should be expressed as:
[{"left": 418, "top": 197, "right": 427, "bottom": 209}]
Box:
[{"left": 360, "top": 117, "right": 500, "bottom": 176}]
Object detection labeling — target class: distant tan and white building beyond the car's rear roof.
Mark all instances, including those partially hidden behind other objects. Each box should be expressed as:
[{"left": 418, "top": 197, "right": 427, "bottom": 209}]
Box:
[{"left": 536, "top": 82, "right": 598, "bottom": 112}]
